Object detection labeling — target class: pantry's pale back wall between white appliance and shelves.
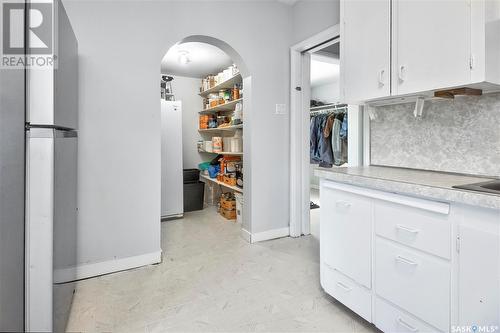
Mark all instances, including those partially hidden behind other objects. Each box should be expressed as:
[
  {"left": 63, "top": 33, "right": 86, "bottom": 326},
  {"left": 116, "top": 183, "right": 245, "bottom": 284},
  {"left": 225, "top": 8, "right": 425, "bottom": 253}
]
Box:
[{"left": 172, "top": 76, "right": 207, "bottom": 169}]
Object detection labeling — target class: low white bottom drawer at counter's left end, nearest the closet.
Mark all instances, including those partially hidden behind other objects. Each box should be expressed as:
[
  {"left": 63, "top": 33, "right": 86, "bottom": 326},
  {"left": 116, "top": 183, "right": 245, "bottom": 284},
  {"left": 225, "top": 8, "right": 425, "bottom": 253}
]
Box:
[{"left": 321, "top": 263, "right": 372, "bottom": 322}]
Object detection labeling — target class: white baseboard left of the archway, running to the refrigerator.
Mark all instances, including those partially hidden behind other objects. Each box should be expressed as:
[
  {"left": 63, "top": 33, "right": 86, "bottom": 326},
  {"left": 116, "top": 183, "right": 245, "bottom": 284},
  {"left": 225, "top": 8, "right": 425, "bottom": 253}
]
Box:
[{"left": 54, "top": 250, "right": 161, "bottom": 283}]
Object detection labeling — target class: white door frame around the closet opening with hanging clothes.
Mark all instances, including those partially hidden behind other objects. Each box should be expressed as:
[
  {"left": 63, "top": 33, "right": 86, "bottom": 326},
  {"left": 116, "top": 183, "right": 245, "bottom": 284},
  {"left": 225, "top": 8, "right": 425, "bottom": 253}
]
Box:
[{"left": 290, "top": 24, "right": 369, "bottom": 237}]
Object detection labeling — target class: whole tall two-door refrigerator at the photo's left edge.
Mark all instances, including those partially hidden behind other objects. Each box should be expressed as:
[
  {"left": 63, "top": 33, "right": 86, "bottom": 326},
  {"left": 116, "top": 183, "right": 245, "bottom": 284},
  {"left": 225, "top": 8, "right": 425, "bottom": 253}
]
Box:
[{"left": 0, "top": 0, "right": 78, "bottom": 332}]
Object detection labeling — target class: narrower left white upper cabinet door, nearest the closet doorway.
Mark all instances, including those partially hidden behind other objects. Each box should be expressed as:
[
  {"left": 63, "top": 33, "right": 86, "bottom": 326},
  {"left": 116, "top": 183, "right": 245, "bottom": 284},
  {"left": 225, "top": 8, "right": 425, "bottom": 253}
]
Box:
[{"left": 340, "top": 0, "right": 391, "bottom": 104}]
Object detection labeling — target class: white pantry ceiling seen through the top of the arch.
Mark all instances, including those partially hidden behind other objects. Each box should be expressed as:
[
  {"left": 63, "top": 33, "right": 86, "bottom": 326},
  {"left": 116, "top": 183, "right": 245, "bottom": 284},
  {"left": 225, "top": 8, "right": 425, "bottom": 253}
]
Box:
[{"left": 161, "top": 42, "right": 233, "bottom": 78}]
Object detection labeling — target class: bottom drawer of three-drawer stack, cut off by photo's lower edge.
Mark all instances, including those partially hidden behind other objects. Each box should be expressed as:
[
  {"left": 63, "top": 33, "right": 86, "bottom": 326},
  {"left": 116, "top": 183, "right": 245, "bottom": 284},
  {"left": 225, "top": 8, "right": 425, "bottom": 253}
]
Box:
[{"left": 374, "top": 297, "right": 438, "bottom": 333}]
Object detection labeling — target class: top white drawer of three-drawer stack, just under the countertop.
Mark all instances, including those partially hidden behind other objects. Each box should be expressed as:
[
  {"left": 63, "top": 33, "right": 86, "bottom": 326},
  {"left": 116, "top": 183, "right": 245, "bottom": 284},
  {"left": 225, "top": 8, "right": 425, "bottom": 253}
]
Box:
[{"left": 374, "top": 201, "right": 451, "bottom": 259}]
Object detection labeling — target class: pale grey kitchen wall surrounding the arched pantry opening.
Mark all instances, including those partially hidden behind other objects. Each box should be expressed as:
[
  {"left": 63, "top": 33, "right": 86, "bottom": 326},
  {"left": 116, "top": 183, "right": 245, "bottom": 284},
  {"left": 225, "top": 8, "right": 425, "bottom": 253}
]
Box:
[{"left": 61, "top": 1, "right": 292, "bottom": 270}]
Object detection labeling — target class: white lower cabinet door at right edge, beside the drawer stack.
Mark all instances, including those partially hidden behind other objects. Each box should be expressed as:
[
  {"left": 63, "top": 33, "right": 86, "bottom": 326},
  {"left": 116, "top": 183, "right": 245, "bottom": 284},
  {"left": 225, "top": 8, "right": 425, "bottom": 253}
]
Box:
[{"left": 458, "top": 208, "right": 500, "bottom": 326}]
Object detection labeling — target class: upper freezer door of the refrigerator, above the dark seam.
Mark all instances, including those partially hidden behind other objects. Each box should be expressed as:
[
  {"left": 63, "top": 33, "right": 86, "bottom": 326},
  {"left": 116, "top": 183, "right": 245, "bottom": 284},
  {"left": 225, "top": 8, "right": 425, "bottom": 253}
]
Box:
[{"left": 27, "top": 0, "right": 78, "bottom": 129}]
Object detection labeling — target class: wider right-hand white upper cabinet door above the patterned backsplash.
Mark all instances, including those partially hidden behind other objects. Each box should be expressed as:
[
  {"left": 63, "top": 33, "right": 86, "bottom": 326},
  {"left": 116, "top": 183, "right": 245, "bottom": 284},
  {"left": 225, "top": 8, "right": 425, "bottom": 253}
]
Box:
[{"left": 392, "top": 0, "right": 471, "bottom": 95}]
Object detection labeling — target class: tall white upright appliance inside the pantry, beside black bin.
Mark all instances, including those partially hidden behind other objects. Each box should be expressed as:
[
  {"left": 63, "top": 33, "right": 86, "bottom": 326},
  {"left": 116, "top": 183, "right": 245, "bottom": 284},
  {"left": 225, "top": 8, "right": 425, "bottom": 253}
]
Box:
[{"left": 161, "top": 99, "right": 184, "bottom": 219}]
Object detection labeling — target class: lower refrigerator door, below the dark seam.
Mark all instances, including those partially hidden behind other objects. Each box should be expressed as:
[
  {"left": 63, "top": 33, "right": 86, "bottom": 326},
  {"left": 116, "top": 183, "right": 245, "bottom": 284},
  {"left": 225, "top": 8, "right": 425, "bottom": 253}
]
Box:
[{"left": 26, "top": 128, "right": 77, "bottom": 331}]
